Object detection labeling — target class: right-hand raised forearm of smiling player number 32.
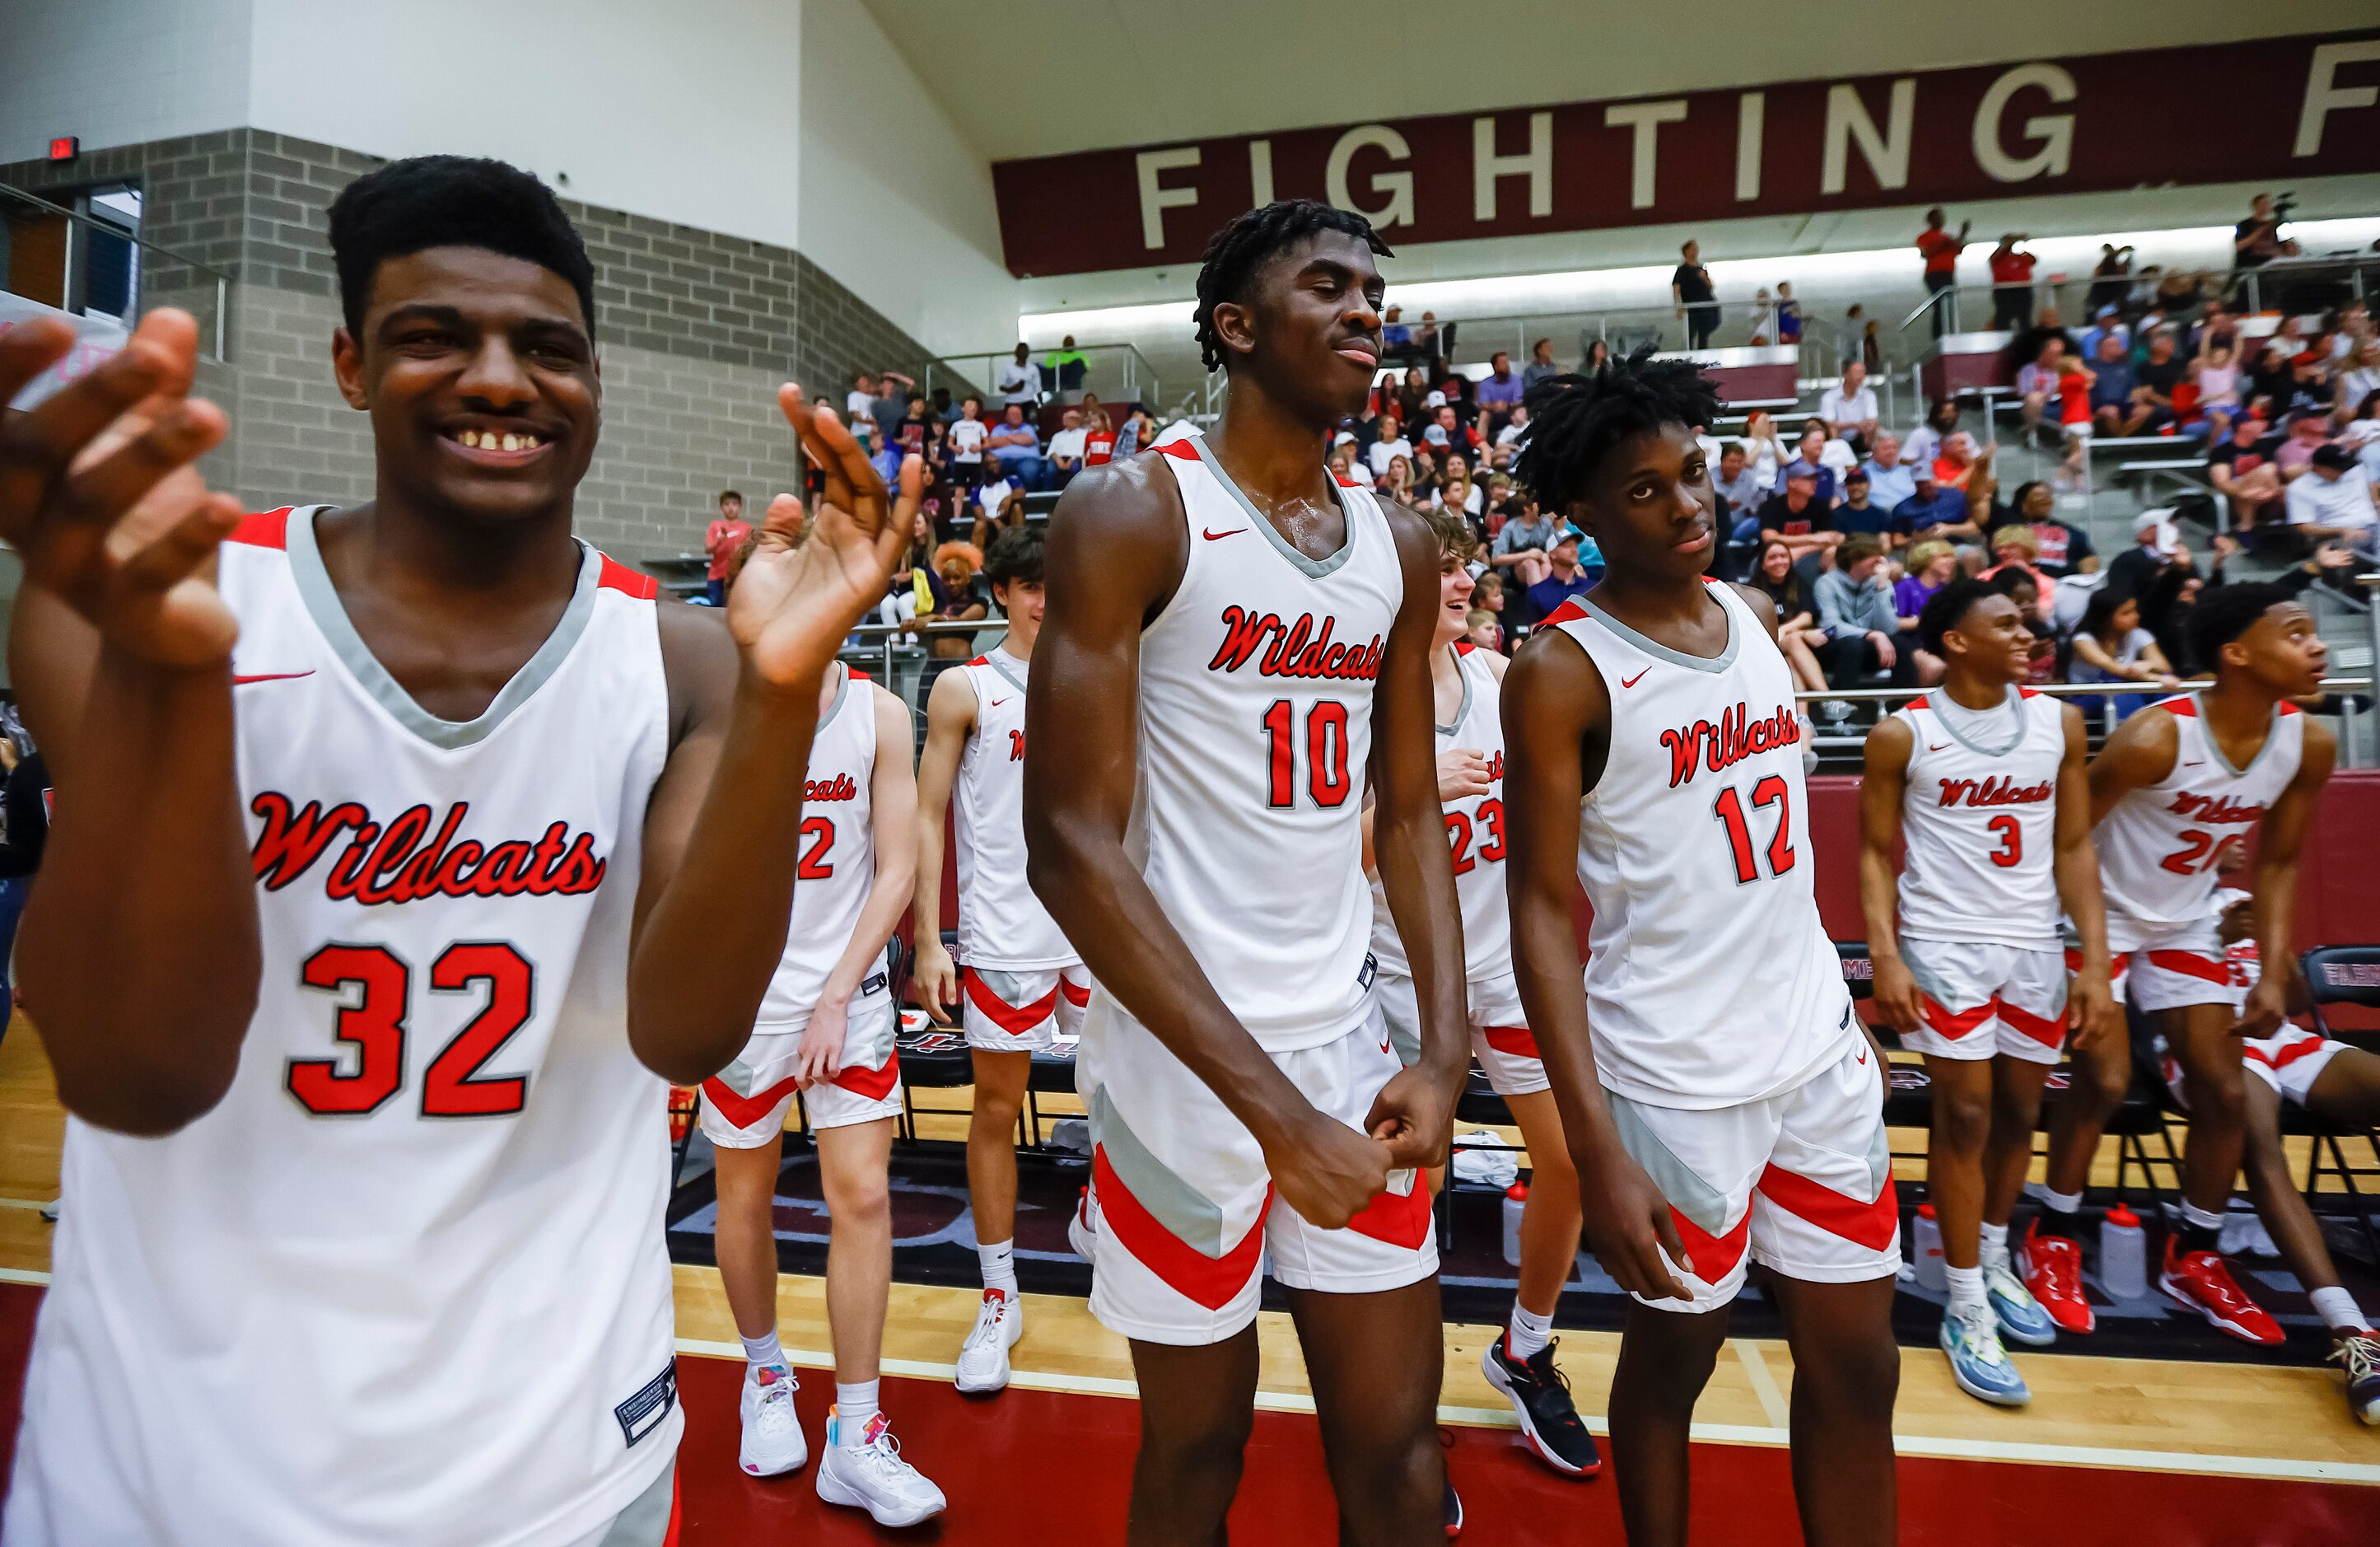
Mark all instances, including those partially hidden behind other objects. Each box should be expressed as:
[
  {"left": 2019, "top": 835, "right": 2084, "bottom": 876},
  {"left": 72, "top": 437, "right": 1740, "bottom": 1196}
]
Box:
[{"left": 628, "top": 666, "right": 819, "bottom": 1085}]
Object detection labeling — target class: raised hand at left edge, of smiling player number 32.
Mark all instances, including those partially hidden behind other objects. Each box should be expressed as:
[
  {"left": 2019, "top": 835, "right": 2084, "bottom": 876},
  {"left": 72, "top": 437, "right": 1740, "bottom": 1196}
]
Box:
[{"left": 0, "top": 310, "right": 240, "bottom": 669}]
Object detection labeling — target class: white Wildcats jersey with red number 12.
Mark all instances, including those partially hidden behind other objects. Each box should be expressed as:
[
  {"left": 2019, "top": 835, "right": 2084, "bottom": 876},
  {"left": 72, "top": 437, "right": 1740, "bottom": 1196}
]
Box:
[{"left": 1547, "top": 581, "right": 1856, "bottom": 1106}]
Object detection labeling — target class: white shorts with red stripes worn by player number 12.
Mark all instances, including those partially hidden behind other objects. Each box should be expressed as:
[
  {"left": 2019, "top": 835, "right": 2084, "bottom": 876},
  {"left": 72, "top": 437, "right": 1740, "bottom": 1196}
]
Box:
[{"left": 1604, "top": 1038, "right": 1902, "bottom": 1311}]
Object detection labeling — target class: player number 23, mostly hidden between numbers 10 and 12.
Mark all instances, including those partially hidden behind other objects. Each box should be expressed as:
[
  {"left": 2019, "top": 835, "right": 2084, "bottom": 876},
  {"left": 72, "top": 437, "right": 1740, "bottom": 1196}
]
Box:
[{"left": 1364, "top": 509, "right": 1604, "bottom": 1475}]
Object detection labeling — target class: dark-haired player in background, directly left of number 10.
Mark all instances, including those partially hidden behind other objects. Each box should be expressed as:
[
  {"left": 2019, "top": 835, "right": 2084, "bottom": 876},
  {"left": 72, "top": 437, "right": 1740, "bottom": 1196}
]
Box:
[{"left": 909, "top": 526, "right": 1090, "bottom": 1392}]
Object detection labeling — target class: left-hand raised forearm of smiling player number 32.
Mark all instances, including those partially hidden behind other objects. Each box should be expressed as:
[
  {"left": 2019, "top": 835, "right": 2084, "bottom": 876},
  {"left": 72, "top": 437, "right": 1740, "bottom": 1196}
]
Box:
[{"left": 16, "top": 647, "right": 262, "bottom": 1133}]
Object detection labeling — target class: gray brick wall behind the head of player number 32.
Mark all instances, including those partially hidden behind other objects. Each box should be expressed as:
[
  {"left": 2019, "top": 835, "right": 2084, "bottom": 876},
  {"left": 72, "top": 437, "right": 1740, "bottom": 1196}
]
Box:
[{"left": 0, "top": 129, "right": 956, "bottom": 559}]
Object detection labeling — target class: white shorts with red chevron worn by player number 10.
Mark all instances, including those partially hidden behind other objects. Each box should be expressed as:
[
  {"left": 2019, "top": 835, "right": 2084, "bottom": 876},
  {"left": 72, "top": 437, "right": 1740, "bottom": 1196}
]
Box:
[{"left": 1076, "top": 998, "right": 1438, "bottom": 1347}]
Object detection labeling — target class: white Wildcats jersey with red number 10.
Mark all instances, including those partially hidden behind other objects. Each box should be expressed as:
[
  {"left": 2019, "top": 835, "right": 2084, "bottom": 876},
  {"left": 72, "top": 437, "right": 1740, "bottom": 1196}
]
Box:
[{"left": 1113, "top": 436, "right": 1404, "bottom": 1052}]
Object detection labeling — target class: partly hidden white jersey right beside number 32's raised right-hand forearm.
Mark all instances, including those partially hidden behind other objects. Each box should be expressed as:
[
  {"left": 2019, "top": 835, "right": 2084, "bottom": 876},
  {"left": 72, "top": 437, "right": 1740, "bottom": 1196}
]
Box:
[{"left": 754, "top": 666, "right": 878, "bottom": 1031}]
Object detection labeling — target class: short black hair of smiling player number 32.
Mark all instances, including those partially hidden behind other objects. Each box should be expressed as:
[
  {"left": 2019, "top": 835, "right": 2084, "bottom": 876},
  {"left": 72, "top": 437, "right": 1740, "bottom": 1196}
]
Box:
[{"left": 331, "top": 155, "right": 595, "bottom": 340}]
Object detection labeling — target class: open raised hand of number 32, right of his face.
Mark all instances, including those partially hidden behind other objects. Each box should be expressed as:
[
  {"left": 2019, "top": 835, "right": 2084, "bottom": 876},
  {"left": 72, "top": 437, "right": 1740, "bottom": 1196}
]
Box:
[{"left": 728, "top": 383, "right": 926, "bottom": 688}]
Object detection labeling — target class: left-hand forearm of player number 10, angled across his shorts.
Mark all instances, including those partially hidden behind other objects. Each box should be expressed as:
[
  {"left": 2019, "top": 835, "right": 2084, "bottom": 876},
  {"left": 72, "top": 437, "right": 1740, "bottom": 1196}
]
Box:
[{"left": 1026, "top": 802, "right": 1314, "bottom": 1145}]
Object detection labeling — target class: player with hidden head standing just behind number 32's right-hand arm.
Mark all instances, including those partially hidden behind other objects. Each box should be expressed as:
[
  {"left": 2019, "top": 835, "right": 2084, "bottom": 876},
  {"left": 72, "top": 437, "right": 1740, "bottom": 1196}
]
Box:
[{"left": 702, "top": 647, "right": 945, "bottom": 1526}]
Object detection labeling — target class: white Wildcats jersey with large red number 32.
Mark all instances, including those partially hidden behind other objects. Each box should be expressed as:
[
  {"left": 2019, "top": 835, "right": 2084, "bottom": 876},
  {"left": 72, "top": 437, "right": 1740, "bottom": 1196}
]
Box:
[{"left": 0, "top": 507, "right": 681, "bottom": 1547}]
